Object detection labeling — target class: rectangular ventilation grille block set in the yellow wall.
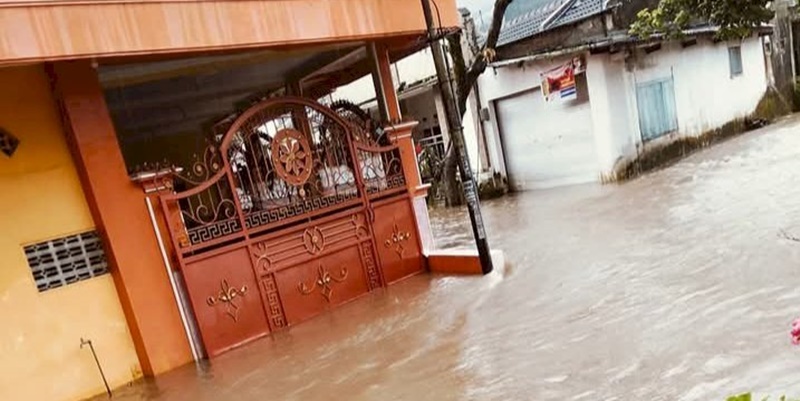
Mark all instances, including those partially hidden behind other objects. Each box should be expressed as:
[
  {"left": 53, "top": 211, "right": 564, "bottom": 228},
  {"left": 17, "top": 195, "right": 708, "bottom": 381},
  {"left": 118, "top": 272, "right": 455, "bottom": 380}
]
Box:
[{"left": 25, "top": 231, "right": 108, "bottom": 292}]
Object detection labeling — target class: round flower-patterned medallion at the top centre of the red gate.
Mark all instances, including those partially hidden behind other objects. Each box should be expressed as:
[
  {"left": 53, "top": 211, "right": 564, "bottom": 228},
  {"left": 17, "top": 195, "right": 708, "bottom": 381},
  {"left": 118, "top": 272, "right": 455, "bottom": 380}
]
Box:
[{"left": 272, "top": 128, "right": 312, "bottom": 186}]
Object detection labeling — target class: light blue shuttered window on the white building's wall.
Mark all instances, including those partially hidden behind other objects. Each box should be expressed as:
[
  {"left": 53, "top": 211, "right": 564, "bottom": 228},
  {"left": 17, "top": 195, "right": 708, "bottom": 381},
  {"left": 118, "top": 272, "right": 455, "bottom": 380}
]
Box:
[{"left": 636, "top": 78, "right": 678, "bottom": 141}]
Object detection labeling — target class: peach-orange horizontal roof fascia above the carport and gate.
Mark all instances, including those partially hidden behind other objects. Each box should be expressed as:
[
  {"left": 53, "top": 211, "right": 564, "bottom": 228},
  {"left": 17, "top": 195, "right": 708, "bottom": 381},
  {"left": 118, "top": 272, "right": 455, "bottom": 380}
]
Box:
[{"left": 0, "top": 0, "right": 458, "bottom": 64}]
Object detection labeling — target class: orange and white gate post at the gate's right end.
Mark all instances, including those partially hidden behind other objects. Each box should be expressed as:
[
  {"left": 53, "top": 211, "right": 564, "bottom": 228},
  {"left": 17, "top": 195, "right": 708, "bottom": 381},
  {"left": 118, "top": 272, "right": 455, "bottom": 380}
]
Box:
[{"left": 384, "top": 121, "right": 435, "bottom": 255}]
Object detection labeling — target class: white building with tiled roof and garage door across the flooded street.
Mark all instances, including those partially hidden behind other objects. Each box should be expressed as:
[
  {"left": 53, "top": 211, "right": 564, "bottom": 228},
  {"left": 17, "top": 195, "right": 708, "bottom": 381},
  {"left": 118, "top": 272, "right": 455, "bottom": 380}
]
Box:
[{"left": 473, "top": 0, "right": 769, "bottom": 190}]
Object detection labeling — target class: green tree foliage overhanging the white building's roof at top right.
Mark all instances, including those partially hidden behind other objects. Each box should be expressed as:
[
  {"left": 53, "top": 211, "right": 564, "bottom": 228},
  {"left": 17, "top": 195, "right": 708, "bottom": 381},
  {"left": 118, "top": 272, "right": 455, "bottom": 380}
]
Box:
[{"left": 630, "top": 0, "right": 774, "bottom": 39}]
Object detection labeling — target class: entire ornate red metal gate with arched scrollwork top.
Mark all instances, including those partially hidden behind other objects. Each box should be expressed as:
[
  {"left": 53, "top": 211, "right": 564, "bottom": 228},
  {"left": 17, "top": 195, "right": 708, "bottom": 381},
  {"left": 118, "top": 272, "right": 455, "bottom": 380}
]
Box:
[{"left": 161, "top": 98, "right": 423, "bottom": 356}]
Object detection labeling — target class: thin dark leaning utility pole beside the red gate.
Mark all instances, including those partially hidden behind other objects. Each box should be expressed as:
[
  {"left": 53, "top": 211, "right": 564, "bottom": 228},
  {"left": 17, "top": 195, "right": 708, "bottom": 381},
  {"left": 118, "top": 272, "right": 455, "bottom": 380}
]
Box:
[{"left": 421, "top": 0, "right": 493, "bottom": 274}]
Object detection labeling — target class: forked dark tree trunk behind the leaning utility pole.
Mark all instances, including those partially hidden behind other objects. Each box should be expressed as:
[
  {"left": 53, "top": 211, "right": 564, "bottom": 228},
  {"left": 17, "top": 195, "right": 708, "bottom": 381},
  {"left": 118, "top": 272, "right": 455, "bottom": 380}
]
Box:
[{"left": 434, "top": 0, "right": 514, "bottom": 206}]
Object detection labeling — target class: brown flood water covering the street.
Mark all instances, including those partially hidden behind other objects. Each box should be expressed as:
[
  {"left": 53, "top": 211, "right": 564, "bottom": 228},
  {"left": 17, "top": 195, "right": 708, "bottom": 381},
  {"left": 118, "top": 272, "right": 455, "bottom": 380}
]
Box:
[{"left": 92, "top": 118, "right": 800, "bottom": 401}]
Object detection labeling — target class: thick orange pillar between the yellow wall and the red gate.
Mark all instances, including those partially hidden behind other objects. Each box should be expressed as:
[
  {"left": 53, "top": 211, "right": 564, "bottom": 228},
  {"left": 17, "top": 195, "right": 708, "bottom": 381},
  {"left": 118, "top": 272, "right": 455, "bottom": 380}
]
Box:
[{"left": 48, "top": 61, "right": 192, "bottom": 375}]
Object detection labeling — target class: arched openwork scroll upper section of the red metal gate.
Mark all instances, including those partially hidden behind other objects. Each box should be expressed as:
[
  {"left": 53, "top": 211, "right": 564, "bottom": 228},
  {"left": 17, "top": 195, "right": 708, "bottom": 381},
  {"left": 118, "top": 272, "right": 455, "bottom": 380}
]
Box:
[{"left": 162, "top": 97, "right": 405, "bottom": 250}]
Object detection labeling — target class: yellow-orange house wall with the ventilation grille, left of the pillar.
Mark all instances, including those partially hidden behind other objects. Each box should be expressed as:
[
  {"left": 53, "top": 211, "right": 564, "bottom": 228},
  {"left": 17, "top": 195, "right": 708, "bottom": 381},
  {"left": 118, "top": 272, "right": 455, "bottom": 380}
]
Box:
[{"left": 0, "top": 65, "right": 141, "bottom": 401}]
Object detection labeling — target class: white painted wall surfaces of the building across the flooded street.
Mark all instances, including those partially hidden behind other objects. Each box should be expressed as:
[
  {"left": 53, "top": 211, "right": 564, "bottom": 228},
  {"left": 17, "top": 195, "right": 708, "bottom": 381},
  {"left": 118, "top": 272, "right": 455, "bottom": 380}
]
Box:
[{"left": 479, "top": 36, "right": 768, "bottom": 184}]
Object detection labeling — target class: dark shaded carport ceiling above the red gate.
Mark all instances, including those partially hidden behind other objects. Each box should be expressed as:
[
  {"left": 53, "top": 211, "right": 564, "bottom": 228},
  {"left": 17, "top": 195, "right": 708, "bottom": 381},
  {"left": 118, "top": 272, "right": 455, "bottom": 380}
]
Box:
[{"left": 98, "top": 43, "right": 366, "bottom": 139}]
